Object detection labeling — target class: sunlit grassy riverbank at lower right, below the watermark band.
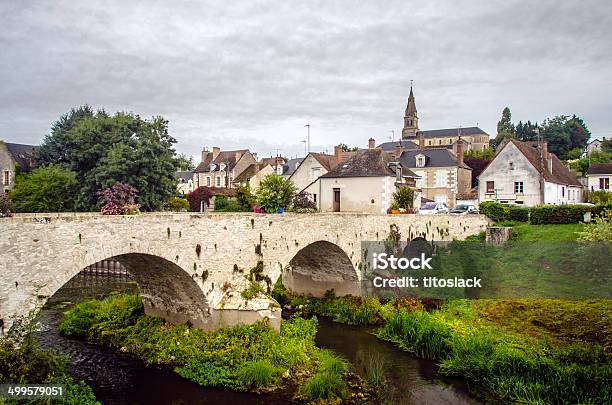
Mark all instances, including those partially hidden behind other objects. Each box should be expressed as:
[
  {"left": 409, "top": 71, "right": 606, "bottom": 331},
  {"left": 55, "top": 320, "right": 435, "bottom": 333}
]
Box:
[{"left": 289, "top": 296, "right": 612, "bottom": 404}]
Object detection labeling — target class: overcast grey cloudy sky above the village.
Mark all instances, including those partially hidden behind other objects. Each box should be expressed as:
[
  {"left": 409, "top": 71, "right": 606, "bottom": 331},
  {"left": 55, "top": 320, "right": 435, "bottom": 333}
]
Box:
[{"left": 0, "top": 0, "right": 612, "bottom": 156}]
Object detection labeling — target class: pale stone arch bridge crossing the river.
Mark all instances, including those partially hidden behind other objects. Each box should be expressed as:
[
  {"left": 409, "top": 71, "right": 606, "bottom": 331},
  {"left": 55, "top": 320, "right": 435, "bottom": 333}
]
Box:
[{"left": 0, "top": 213, "right": 488, "bottom": 333}]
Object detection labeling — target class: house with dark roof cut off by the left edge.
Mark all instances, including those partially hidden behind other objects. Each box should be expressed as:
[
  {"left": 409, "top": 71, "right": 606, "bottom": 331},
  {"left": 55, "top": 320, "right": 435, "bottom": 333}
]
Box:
[{"left": 0, "top": 141, "right": 37, "bottom": 193}]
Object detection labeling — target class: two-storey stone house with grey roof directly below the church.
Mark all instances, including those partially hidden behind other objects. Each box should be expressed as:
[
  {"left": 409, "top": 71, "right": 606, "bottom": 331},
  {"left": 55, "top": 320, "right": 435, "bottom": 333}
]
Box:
[{"left": 394, "top": 137, "right": 472, "bottom": 207}]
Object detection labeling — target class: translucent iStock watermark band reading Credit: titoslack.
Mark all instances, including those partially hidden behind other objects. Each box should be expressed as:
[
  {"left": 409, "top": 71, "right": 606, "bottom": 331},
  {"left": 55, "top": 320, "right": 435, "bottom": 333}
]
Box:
[{"left": 359, "top": 238, "right": 612, "bottom": 299}]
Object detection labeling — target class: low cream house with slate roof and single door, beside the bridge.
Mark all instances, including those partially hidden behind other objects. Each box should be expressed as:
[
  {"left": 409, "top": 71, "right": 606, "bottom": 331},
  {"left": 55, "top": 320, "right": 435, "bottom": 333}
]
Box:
[{"left": 316, "top": 148, "right": 417, "bottom": 214}]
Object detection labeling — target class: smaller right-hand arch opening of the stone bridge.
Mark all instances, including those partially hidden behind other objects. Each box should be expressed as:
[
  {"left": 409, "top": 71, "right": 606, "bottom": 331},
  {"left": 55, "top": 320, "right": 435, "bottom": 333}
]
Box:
[{"left": 282, "top": 240, "right": 361, "bottom": 297}]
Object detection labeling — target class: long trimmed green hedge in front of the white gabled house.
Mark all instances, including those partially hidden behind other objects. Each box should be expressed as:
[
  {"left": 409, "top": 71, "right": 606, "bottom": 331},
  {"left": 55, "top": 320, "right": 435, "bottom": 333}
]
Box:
[{"left": 480, "top": 201, "right": 612, "bottom": 225}]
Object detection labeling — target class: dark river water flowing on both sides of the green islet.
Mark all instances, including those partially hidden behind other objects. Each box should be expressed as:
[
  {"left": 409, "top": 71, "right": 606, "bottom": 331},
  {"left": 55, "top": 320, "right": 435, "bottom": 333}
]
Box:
[{"left": 39, "top": 275, "right": 479, "bottom": 405}]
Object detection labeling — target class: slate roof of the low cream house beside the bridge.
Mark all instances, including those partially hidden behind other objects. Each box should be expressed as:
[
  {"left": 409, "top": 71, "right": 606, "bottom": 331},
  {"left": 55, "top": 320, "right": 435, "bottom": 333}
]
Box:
[{"left": 321, "top": 148, "right": 416, "bottom": 178}]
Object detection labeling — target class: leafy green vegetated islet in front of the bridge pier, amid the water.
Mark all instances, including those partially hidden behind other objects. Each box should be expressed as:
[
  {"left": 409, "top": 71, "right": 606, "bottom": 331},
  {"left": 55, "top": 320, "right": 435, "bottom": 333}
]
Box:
[{"left": 59, "top": 295, "right": 367, "bottom": 402}]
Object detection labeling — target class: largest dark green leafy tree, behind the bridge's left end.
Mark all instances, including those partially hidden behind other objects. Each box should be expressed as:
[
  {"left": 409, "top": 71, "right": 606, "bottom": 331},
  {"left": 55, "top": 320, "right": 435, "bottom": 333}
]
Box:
[{"left": 37, "top": 106, "right": 178, "bottom": 211}]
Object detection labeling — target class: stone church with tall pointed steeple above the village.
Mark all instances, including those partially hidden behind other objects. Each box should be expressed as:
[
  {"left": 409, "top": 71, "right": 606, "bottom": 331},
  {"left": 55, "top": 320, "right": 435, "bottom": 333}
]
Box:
[{"left": 378, "top": 86, "right": 489, "bottom": 152}]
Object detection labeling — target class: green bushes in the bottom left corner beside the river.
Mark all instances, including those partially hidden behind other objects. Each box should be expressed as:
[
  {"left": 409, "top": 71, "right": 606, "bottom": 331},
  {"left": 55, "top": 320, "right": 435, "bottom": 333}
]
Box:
[{"left": 0, "top": 320, "right": 99, "bottom": 405}]
